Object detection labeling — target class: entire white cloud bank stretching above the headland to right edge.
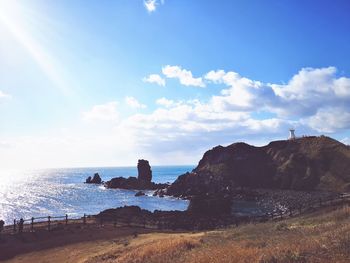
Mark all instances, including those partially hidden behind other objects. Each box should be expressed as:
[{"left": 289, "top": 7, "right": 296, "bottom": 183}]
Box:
[{"left": 80, "top": 65, "right": 350, "bottom": 163}]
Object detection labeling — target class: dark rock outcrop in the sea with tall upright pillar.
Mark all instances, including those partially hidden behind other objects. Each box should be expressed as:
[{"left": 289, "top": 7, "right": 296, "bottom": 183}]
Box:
[{"left": 105, "top": 160, "right": 169, "bottom": 190}]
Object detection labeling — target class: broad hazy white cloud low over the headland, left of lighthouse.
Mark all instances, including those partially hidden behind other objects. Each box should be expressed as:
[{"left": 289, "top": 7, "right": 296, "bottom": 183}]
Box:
[{"left": 118, "top": 98, "right": 290, "bottom": 158}]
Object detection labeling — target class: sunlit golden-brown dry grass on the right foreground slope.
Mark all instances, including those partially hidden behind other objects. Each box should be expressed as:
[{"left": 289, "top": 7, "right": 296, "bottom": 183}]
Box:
[{"left": 89, "top": 206, "right": 350, "bottom": 263}]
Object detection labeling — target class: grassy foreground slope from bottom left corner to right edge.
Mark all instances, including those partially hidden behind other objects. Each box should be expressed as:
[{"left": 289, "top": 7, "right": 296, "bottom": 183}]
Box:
[{"left": 5, "top": 206, "right": 350, "bottom": 263}]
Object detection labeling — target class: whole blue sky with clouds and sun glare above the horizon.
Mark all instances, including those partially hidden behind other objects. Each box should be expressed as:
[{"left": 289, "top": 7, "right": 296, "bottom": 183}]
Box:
[{"left": 0, "top": 0, "right": 350, "bottom": 169}]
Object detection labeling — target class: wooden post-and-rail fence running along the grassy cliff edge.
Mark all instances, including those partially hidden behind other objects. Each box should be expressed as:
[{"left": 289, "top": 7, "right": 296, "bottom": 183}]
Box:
[{"left": 0, "top": 193, "right": 350, "bottom": 234}]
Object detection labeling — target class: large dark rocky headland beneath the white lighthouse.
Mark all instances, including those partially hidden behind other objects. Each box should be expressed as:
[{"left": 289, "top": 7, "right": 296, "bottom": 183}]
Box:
[{"left": 167, "top": 136, "right": 350, "bottom": 196}]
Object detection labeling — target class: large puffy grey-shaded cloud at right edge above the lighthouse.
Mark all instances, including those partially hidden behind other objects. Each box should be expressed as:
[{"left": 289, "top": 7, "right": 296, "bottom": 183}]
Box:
[{"left": 269, "top": 67, "right": 350, "bottom": 118}]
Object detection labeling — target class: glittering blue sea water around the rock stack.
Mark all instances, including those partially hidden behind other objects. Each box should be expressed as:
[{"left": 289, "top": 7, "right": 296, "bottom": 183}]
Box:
[{"left": 0, "top": 166, "right": 194, "bottom": 224}]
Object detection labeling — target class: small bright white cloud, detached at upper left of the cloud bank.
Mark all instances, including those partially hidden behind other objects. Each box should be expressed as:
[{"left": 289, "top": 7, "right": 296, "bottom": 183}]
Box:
[{"left": 162, "top": 65, "right": 205, "bottom": 87}]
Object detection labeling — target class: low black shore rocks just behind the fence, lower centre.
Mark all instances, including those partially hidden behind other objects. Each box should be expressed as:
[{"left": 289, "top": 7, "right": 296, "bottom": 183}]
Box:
[{"left": 96, "top": 196, "right": 238, "bottom": 230}]
